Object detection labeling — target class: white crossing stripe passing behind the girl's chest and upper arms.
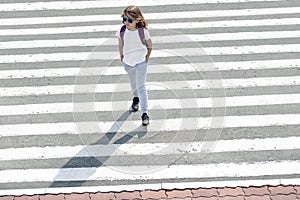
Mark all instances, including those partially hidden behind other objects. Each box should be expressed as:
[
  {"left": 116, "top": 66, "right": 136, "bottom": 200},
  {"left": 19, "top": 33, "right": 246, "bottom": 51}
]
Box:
[{"left": 0, "top": 31, "right": 300, "bottom": 49}]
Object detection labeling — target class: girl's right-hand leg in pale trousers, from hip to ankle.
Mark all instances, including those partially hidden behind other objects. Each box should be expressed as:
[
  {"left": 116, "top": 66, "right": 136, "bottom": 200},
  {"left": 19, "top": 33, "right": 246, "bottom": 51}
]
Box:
[{"left": 136, "top": 61, "right": 148, "bottom": 113}]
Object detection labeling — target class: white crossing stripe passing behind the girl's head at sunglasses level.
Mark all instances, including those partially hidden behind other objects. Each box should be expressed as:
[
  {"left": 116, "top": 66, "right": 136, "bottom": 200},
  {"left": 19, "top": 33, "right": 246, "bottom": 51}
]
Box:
[{"left": 0, "top": 7, "right": 300, "bottom": 26}]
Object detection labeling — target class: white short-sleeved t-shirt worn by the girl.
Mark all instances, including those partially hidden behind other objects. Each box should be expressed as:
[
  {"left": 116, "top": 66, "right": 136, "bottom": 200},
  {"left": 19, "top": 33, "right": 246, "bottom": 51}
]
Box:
[{"left": 116, "top": 28, "right": 150, "bottom": 66}]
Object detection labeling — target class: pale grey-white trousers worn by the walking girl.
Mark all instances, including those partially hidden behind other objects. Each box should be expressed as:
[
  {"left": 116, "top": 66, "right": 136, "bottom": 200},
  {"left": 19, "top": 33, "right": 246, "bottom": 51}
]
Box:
[{"left": 123, "top": 61, "right": 148, "bottom": 113}]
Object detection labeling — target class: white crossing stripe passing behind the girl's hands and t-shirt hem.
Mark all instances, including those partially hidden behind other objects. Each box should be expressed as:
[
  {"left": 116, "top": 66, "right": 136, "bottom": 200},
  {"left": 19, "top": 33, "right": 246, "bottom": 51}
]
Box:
[{"left": 0, "top": 44, "right": 300, "bottom": 63}]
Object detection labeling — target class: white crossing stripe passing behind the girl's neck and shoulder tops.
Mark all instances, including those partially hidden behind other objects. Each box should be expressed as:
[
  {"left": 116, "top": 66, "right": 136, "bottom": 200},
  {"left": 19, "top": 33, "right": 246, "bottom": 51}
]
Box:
[{"left": 0, "top": 18, "right": 300, "bottom": 36}]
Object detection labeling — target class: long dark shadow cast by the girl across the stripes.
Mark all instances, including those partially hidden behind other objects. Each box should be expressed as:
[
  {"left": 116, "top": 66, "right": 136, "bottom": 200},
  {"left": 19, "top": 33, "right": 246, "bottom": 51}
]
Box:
[{"left": 49, "top": 111, "right": 147, "bottom": 188}]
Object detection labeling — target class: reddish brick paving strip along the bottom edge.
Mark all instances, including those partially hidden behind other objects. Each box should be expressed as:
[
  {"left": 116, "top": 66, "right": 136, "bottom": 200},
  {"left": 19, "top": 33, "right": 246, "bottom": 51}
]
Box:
[{"left": 0, "top": 185, "right": 300, "bottom": 200}]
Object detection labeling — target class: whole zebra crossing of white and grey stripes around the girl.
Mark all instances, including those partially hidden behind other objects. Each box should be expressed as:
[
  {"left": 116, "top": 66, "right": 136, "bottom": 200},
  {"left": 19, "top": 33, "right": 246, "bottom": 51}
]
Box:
[{"left": 0, "top": 0, "right": 300, "bottom": 195}]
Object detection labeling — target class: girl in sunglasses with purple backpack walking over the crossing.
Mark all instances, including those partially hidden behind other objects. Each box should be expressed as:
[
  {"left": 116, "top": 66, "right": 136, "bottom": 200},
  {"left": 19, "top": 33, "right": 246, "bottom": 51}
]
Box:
[{"left": 117, "top": 6, "right": 152, "bottom": 126}]
